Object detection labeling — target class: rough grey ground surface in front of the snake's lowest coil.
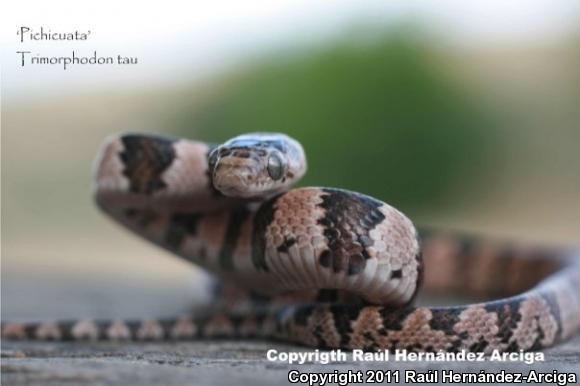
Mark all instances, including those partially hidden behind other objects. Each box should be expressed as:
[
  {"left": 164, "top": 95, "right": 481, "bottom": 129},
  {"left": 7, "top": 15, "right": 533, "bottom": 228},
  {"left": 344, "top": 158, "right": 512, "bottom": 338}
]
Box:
[{"left": 2, "top": 337, "right": 580, "bottom": 386}]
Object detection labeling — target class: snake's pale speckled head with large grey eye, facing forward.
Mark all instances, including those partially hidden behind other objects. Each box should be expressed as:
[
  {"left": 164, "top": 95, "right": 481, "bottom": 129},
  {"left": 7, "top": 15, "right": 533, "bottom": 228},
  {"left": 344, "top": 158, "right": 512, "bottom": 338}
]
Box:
[{"left": 208, "top": 133, "right": 306, "bottom": 198}]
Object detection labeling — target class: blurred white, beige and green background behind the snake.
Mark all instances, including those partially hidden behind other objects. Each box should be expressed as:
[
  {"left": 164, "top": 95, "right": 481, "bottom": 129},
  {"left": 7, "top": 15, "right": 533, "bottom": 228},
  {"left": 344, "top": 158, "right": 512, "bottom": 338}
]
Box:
[{"left": 1, "top": 0, "right": 580, "bottom": 318}]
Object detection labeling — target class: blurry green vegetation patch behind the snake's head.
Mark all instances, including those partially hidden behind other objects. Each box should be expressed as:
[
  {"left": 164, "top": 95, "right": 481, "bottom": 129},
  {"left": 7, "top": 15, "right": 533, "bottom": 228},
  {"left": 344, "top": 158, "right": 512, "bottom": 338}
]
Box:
[{"left": 177, "top": 33, "right": 493, "bottom": 212}]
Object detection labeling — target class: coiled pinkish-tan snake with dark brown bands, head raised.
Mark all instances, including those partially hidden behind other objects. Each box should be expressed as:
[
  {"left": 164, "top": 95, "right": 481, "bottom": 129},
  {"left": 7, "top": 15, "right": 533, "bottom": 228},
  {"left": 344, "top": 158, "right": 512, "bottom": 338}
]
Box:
[{"left": 2, "top": 133, "right": 580, "bottom": 352}]
